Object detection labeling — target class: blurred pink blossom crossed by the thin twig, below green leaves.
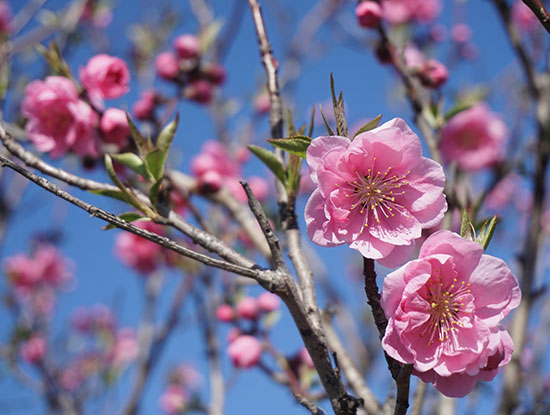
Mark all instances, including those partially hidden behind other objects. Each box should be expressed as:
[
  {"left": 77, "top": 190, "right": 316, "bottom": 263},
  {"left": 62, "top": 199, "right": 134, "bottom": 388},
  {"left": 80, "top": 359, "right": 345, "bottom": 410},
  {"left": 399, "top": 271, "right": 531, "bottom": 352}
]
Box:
[{"left": 115, "top": 221, "right": 164, "bottom": 274}]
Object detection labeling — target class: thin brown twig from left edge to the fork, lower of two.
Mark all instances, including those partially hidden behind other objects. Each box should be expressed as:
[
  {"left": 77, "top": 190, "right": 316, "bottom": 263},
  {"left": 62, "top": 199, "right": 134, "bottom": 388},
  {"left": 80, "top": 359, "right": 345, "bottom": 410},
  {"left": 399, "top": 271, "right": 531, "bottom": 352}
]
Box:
[{"left": 0, "top": 155, "right": 262, "bottom": 279}]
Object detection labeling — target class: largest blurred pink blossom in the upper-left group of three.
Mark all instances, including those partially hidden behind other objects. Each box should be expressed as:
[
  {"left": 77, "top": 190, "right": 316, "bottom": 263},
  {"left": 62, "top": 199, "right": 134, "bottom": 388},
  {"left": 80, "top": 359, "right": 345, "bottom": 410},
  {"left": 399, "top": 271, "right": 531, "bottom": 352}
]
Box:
[{"left": 22, "top": 76, "right": 97, "bottom": 157}]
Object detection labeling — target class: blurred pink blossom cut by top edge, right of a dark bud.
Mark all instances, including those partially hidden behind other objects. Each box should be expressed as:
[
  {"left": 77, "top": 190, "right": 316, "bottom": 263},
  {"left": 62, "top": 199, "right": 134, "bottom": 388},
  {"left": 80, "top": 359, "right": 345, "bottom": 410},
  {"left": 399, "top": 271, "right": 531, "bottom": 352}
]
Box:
[{"left": 382, "top": 0, "right": 442, "bottom": 24}]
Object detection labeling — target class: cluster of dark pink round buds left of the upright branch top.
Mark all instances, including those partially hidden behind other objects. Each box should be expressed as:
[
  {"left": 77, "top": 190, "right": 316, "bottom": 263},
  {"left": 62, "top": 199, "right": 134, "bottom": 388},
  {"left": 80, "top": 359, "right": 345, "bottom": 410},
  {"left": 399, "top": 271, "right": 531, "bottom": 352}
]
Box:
[{"left": 155, "top": 34, "right": 225, "bottom": 104}]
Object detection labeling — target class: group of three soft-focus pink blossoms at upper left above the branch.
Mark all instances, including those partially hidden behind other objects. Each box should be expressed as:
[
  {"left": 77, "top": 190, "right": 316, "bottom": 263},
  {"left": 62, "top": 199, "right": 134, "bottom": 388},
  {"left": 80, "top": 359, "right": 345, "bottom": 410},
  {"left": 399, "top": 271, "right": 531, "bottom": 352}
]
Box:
[{"left": 22, "top": 54, "right": 130, "bottom": 158}]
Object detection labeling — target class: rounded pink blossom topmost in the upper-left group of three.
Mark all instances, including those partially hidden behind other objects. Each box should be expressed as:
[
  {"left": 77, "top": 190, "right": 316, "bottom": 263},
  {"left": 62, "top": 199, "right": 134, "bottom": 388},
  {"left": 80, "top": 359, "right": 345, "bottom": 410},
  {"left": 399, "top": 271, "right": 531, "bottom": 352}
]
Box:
[{"left": 79, "top": 54, "right": 130, "bottom": 108}]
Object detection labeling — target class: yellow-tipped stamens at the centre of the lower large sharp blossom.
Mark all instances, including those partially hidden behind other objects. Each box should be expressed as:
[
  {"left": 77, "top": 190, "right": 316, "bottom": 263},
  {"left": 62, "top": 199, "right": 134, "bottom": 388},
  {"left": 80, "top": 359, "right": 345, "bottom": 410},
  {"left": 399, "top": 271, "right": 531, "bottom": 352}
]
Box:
[{"left": 420, "top": 269, "right": 472, "bottom": 347}]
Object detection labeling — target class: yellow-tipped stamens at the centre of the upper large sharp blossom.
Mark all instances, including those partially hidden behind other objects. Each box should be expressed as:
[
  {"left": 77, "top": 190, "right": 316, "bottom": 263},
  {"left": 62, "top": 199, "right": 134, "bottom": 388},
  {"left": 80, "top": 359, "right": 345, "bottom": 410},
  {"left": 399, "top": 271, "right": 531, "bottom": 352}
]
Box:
[{"left": 338, "top": 157, "right": 411, "bottom": 233}]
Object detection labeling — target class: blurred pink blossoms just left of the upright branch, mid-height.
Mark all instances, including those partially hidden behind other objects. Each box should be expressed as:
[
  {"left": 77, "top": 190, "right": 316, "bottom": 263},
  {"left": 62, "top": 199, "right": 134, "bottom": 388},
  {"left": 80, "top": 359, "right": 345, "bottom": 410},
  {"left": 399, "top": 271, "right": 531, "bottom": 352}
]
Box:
[{"left": 191, "top": 140, "right": 268, "bottom": 203}]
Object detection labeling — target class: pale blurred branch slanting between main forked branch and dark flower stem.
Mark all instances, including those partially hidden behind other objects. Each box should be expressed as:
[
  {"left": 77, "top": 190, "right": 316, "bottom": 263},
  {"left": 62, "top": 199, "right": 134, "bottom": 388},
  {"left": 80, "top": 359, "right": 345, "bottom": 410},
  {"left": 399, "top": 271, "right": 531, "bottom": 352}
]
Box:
[{"left": 323, "top": 313, "right": 382, "bottom": 415}]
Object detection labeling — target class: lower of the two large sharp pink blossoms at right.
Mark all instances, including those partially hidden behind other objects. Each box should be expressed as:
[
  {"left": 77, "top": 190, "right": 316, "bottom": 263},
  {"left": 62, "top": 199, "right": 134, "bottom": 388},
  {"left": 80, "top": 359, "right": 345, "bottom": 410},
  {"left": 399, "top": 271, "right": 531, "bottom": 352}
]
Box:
[{"left": 382, "top": 230, "right": 521, "bottom": 397}]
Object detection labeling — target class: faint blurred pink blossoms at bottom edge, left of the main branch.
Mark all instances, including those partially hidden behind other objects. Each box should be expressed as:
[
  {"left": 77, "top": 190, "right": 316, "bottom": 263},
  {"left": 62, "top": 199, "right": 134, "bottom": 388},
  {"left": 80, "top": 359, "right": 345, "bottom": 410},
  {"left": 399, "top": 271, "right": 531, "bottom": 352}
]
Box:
[{"left": 159, "top": 363, "right": 202, "bottom": 414}]
